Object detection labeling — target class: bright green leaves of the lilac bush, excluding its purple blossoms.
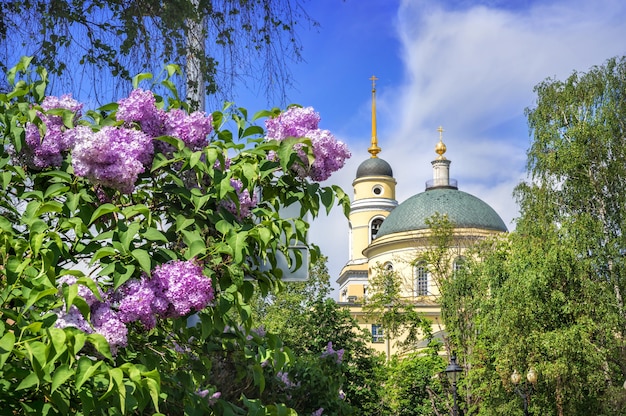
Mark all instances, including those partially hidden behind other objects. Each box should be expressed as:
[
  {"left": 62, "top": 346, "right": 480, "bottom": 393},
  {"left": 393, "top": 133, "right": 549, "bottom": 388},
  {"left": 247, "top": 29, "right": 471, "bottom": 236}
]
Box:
[{"left": 0, "top": 58, "right": 346, "bottom": 415}]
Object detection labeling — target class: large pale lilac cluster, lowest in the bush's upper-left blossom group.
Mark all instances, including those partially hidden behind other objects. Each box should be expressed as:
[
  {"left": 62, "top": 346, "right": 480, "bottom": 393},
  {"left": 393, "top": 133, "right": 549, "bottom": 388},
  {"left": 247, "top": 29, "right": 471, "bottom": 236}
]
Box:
[{"left": 72, "top": 126, "right": 154, "bottom": 193}]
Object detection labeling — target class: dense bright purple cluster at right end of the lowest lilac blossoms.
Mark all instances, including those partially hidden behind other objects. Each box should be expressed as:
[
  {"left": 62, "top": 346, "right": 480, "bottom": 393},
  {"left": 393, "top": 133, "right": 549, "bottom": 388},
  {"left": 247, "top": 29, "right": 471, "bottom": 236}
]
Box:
[{"left": 119, "top": 260, "right": 215, "bottom": 328}]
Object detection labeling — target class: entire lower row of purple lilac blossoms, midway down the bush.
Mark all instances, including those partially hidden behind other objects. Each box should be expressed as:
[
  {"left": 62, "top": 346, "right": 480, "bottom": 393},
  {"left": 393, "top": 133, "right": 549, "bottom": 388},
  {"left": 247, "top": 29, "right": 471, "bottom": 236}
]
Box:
[{"left": 55, "top": 260, "right": 215, "bottom": 354}]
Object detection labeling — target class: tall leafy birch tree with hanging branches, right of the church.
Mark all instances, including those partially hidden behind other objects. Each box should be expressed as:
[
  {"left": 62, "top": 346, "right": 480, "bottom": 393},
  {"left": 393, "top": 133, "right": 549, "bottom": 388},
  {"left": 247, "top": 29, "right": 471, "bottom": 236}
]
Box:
[{"left": 442, "top": 58, "right": 626, "bottom": 416}]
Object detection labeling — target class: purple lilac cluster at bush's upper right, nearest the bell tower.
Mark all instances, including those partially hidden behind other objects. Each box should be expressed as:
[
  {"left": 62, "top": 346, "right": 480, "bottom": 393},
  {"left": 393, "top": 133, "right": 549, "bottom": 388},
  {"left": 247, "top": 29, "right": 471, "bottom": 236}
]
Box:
[{"left": 265, "top": 107, "right": 351, "bottom": 182}]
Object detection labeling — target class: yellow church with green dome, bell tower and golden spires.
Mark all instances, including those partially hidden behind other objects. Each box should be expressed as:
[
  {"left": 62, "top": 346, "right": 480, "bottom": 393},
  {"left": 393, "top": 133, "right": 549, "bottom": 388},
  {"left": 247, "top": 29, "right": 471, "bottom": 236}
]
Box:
[{"left": 337, "top": 82, "right": 507, "bottom": 357}]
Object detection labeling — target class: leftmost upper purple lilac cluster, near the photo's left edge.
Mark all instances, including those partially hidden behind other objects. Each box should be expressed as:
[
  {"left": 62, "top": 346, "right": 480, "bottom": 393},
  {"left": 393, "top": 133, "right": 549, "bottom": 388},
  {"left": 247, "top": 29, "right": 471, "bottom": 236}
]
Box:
[{"left": 26, "top": 94, "right": 83, "bottom": 169}]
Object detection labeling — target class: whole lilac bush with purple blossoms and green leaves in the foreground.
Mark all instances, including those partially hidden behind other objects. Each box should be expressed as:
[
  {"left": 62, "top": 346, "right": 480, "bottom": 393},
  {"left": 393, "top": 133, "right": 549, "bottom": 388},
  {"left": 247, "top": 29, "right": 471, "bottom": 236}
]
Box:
[{"left": 0, "top": 59, "right": 349, "bottom": 415}]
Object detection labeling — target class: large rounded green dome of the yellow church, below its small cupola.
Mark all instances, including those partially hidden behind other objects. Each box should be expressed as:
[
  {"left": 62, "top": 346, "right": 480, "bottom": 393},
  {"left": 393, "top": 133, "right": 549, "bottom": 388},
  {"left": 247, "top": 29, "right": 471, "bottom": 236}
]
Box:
[{"left": 376, "top": 188, "right": 507, "bottom": 239}]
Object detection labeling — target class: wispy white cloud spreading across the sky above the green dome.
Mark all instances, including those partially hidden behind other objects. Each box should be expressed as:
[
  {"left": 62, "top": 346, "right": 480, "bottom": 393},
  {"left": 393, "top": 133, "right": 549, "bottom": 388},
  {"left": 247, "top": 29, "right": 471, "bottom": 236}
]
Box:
[{"left": 312, "top": 0, "right": 626, "bottom": 292}]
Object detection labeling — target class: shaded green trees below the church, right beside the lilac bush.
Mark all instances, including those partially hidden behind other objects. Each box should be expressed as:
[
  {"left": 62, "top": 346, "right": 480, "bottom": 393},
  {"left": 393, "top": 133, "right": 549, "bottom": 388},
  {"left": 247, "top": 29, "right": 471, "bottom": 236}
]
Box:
[{"left": 254, "top": 257, "right": 387, "bottom": 415}]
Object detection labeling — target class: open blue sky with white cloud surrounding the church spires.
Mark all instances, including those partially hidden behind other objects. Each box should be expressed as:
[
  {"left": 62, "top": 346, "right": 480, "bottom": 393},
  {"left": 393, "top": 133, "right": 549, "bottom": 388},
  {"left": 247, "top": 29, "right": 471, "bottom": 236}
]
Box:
[{"left": 237, "top": 0, "right": 626, "bottom": 290}]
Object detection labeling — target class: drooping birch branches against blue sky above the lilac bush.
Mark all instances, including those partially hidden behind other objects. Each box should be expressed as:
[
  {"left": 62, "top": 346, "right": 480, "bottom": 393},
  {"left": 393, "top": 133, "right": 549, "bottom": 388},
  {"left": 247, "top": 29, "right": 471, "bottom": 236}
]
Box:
[{"left": 0, "top": 0, "right": 316, "bottom": 104}]
